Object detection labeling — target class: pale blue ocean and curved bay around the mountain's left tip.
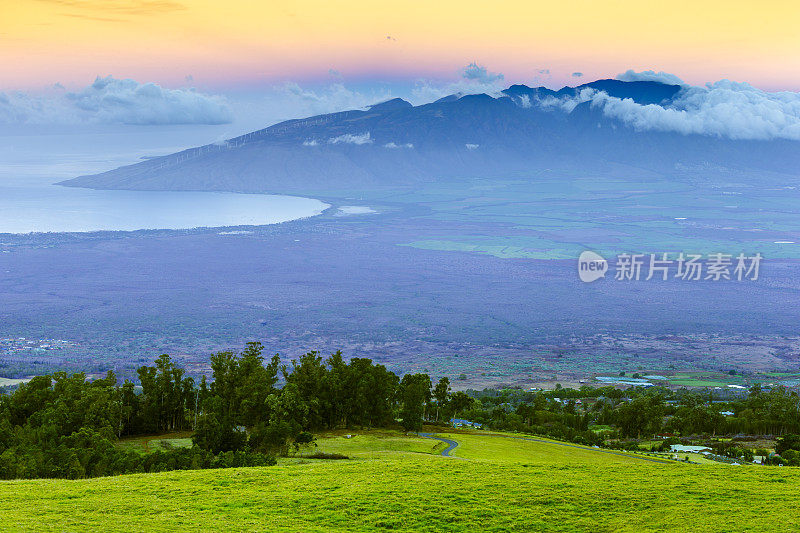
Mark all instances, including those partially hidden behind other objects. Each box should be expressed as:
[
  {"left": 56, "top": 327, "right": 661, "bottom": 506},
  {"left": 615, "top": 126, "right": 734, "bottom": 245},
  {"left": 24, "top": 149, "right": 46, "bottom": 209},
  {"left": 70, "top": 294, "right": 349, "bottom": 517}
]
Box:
[{"left": 0, "top": 126, "right": 329, "bottom": 234}]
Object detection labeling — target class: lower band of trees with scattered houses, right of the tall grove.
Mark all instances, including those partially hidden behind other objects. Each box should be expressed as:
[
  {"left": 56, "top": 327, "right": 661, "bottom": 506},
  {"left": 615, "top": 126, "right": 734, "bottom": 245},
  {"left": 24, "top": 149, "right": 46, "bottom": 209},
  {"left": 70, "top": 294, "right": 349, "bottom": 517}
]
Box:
[{"left": 450, "top": 386, "right": 800, "bottom": 448}]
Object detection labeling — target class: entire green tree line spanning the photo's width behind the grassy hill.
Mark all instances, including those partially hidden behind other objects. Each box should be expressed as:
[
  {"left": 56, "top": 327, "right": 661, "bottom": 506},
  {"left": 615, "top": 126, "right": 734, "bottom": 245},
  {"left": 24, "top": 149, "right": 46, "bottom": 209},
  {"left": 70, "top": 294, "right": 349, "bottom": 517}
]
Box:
[{"left": 0, "top": 343, "right": 800, "bottom": 479}]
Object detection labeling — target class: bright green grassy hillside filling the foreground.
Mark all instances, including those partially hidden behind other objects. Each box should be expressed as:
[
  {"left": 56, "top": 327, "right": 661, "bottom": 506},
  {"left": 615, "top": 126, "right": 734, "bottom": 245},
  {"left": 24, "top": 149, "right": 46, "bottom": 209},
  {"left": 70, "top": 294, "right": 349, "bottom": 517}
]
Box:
[{"left": 0, "top": 433, "right": 800, "bottom": 531}]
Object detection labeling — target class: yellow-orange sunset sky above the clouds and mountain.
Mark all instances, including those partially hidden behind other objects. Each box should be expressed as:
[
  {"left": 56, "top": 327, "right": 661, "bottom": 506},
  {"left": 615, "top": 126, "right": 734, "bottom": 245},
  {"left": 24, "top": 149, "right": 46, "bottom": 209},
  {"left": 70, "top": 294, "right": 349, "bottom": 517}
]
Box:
[{"left": 0, "top": 0, "right": 800, "bottom": 90}]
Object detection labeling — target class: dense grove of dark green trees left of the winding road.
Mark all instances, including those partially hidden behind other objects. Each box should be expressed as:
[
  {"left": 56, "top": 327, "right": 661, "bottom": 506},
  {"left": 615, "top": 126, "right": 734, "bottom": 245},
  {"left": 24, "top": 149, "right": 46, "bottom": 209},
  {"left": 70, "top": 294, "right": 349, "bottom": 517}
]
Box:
[{"left": 0, "top": 343, "right": 446, "bottom": 478}]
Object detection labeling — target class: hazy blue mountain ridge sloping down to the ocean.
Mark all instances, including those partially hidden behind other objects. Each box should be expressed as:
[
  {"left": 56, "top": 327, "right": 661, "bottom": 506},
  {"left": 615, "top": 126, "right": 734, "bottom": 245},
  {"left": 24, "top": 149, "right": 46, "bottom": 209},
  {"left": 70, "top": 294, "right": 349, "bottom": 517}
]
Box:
[{"left": 61, "top": 80, "right": 800, "bottom": 193}]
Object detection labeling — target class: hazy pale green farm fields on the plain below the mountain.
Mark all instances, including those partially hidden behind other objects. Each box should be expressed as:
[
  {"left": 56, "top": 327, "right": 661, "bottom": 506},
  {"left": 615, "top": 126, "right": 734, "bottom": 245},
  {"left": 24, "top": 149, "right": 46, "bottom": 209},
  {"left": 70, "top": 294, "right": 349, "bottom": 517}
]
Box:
[{"left": 388, "top": 177, "right": 798, "bottom": 259}]
